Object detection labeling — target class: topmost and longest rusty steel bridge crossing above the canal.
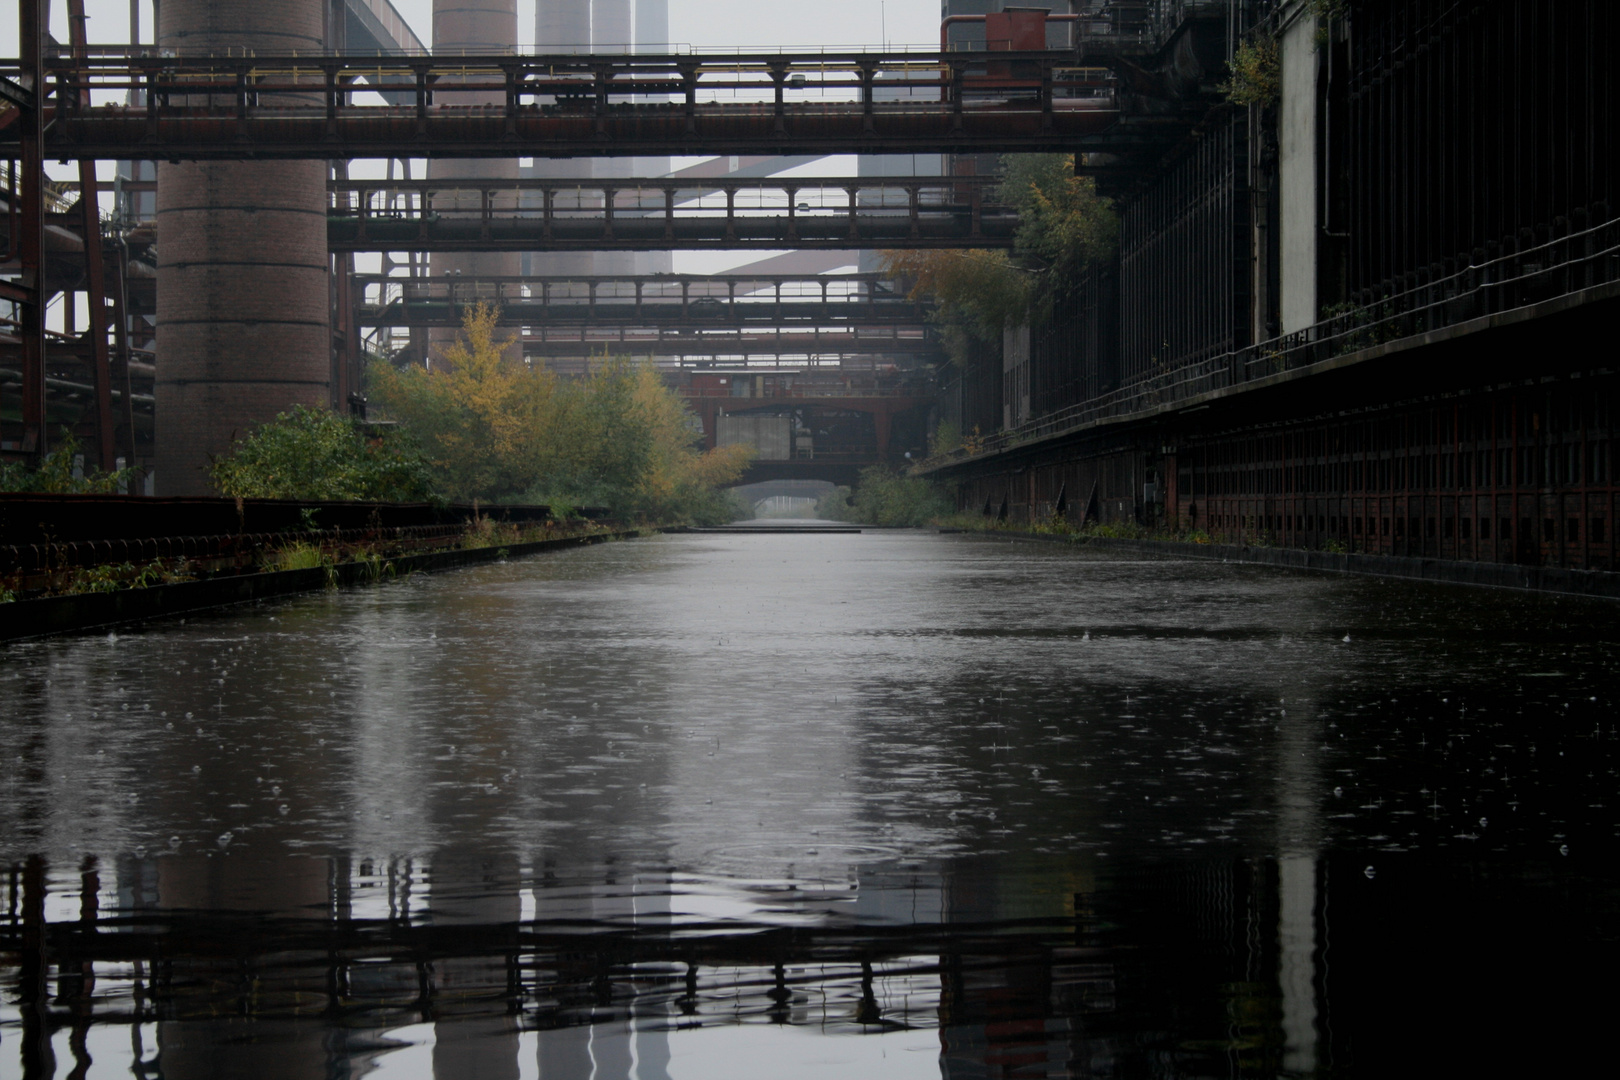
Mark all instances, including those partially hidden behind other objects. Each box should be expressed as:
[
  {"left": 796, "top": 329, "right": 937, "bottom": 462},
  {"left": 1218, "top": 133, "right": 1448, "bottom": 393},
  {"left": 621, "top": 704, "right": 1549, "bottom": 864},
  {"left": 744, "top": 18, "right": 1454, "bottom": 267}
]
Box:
[{"left": 12, "top": 47, "right": 1127, "bottom": 160}]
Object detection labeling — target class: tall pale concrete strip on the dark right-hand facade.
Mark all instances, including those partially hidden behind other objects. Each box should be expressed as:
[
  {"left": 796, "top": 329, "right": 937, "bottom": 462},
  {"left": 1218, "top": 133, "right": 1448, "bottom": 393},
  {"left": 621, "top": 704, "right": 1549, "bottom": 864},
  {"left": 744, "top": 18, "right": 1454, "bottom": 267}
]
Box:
[{"left": 1277, "top": 3, "right": 1322, "bottom": 334}]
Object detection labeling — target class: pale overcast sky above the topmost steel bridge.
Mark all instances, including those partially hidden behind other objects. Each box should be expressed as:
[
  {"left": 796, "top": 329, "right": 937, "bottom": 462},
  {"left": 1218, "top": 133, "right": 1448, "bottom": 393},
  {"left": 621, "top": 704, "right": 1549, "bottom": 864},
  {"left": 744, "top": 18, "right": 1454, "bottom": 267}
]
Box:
[{"left": 0, "top": 0, "right": 940, "bottom": 57}]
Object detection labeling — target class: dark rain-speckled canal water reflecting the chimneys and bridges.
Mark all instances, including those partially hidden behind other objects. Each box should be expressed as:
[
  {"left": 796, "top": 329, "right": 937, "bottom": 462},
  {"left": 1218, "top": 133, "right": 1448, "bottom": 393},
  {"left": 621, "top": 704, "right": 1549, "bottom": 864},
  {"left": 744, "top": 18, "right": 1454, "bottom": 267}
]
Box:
[{"left": 0, "top": 533, "right": 1620, "bottom": 1080}]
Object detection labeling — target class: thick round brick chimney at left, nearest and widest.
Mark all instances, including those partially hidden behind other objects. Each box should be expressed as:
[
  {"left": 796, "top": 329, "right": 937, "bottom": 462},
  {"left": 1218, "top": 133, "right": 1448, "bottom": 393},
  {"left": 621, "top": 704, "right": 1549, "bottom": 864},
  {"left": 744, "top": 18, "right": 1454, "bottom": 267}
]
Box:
[{"left": 156, "top": 0, "right": 332, "bottom": 495}]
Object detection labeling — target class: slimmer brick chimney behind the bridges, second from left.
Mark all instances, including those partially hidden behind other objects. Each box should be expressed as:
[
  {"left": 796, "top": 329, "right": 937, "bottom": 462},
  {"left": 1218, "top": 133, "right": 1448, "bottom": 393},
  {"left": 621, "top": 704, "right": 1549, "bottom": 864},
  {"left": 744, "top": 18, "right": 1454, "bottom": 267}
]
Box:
[{"left": 428, "top": 0, "right": 523, "bottom": 359}]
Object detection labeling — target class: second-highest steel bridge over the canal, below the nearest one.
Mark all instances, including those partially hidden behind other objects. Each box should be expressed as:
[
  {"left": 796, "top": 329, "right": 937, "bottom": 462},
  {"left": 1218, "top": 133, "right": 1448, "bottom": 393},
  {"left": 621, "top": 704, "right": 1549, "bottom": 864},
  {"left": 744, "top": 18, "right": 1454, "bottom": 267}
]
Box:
[{"left": 327, "top": 176, "right": 1017, "bottom": 251}]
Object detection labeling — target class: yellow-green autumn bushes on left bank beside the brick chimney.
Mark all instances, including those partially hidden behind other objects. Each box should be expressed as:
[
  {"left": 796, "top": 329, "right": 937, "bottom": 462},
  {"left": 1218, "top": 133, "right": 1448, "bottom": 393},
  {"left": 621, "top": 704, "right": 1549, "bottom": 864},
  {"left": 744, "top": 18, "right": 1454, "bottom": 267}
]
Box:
[{"left": 212, "top": 304, "right": 752, "bottom": 525}]
